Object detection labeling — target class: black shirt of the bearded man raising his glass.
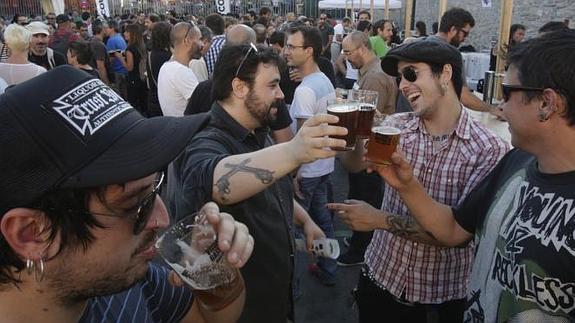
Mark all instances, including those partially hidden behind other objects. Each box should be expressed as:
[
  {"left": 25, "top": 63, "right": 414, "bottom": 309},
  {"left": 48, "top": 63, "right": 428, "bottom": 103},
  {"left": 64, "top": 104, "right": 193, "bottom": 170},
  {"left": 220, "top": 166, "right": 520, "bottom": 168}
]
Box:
[{"left": 167, "top": 103, "right": 293, "bottom": 323}]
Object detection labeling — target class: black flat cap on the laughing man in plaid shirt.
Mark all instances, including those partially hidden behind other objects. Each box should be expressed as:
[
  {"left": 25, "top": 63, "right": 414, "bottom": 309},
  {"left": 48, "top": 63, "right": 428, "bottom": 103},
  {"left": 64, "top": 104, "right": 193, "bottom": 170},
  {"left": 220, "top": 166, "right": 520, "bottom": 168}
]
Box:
[{"left": 381, "top": 38, "right": 462, "bottom": 76}]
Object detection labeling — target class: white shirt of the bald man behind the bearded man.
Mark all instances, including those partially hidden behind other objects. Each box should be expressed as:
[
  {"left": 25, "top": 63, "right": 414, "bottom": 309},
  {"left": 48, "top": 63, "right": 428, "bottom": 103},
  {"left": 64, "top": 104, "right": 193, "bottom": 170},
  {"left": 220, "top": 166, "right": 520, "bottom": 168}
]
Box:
[{"left": 158, "top": 60, "right": 199, "bottom": 117}]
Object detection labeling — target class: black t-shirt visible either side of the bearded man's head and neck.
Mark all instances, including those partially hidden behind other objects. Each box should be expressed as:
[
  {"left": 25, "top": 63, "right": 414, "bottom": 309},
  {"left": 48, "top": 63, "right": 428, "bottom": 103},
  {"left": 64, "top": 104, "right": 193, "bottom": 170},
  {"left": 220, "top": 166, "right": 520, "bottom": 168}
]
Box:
[{"left": 184, "top": 80, "right": 292, "bottom": 130}]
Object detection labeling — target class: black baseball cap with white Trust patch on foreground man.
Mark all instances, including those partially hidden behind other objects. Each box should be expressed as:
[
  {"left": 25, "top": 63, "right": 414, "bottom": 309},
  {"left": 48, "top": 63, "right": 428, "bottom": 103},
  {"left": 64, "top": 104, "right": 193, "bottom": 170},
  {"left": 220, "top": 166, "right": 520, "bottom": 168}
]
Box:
[{"left": 0, "top": 66, "right": 207, "bottom": 216}]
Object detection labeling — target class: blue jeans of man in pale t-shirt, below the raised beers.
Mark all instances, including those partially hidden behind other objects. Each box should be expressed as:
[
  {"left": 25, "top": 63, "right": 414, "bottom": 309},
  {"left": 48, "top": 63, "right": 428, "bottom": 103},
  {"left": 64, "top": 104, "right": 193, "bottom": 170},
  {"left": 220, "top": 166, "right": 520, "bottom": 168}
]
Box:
[{"left": 298, "top": 174, "right": 337, "bottom": 278}]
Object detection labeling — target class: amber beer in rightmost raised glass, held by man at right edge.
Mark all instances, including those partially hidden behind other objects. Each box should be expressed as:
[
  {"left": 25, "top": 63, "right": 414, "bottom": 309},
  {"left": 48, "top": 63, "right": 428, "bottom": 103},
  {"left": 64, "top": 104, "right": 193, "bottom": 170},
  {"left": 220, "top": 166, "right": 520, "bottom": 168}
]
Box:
[{"left": 366, "top": 126, "right": 401, "bottom": 165}]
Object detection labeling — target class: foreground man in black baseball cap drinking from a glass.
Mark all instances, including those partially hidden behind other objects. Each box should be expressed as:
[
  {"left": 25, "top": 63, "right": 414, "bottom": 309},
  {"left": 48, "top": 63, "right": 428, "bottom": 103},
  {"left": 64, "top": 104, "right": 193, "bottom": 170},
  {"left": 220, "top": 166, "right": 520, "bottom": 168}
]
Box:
[{"left": 0, "top": 66, "right": 253, "bottom": 322}]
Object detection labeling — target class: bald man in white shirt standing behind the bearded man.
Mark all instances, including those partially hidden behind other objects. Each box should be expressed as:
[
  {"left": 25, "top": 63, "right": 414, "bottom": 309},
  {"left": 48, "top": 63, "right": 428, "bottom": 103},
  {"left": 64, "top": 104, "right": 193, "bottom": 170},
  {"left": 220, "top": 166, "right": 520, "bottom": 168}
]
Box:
[{"left": 158, "top": 22, "right": 202, "bottom": 117}]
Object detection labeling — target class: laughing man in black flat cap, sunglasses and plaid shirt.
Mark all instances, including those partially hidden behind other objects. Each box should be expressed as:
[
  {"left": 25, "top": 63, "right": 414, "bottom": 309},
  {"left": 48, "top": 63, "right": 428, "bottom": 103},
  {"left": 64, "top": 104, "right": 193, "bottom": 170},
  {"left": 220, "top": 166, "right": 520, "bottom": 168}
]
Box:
[{"left": 330, "top": 40, "right": 508, "bottom": 323}]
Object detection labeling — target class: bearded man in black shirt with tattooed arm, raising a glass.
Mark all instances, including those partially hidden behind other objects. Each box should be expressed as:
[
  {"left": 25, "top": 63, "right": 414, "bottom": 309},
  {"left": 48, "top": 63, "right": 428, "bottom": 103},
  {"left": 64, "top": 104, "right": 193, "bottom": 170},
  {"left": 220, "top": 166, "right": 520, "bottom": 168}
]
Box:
[{"left": 164, "top": 44, "right": 346, "bottom": 323}]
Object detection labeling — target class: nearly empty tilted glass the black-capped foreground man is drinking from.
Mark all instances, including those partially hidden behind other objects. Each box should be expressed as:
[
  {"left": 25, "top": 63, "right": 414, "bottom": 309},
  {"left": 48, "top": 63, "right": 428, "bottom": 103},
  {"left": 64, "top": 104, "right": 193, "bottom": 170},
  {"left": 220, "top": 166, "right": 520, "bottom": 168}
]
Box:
[{"left": 156, "top": 213, "right": 241, "bottom": 308}]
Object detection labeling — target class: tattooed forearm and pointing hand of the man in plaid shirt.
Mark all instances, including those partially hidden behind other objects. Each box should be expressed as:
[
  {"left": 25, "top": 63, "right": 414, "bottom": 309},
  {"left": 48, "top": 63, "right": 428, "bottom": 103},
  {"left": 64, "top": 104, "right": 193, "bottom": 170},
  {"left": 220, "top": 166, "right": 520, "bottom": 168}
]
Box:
[{"left": 328, "top": 200, "right": 468, "bottom": 246}]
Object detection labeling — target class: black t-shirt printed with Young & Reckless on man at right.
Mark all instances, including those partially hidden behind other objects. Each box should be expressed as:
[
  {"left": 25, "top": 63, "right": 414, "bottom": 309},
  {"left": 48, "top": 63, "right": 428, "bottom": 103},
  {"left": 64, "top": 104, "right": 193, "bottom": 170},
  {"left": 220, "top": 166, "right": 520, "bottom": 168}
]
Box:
[{"left": 454, "top": 149, "right": 575, "bottom": 322}]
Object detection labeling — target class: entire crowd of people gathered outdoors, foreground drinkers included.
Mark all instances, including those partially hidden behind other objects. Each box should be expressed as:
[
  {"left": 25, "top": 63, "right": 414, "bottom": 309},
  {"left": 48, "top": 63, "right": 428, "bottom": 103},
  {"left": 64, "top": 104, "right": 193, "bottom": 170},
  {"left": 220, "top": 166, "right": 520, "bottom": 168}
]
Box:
[{"left": 0, "top": 7, "right": 575, "bottom": 323}]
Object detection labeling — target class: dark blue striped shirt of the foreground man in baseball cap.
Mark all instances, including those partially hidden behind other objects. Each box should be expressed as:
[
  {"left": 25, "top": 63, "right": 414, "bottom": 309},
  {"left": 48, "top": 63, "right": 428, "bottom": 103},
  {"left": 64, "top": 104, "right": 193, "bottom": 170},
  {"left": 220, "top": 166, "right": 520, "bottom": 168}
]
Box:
[{"left": 79, "top": 264, "right": 193, "bottom": 323}]
